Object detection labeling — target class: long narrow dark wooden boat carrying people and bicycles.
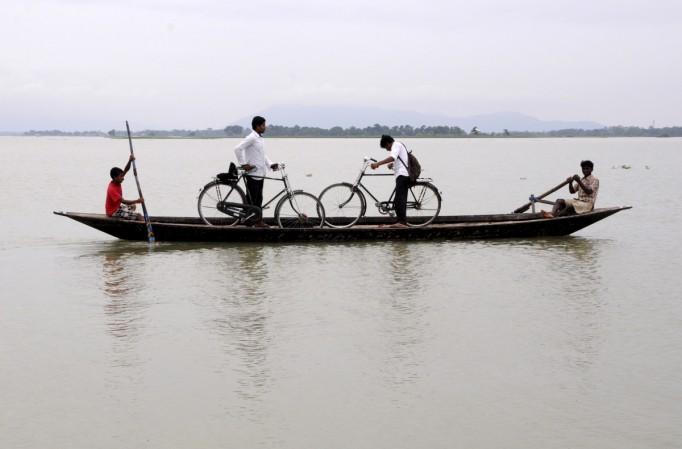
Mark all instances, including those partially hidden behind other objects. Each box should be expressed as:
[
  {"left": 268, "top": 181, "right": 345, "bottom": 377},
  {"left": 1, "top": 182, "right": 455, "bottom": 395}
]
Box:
[{"left": 54, "top": 206, "right": 630, "bottom": 242}]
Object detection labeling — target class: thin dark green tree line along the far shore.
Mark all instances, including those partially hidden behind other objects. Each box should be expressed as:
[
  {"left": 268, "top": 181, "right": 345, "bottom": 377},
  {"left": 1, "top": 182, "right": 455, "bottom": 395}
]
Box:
[{"left": 18, "top": 124, "right": 682, "bottom": 139}]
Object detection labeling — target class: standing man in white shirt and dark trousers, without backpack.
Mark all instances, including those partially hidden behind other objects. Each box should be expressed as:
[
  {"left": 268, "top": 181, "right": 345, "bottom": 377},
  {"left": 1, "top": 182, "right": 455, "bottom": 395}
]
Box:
[{"left": 234, "top": 115, "right": 277, "bottom": 227}]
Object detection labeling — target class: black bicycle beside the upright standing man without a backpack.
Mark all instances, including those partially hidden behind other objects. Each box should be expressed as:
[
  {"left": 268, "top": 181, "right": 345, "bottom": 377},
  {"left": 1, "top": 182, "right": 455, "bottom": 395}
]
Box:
[{"left": 197, "top": 163, "right": 325, "bottom": 228}]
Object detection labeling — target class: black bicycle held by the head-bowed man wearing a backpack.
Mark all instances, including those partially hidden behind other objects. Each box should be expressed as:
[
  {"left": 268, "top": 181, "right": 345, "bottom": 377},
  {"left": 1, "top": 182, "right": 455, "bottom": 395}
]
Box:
[{"left": 319, "top": 157, "right": 441, "bottom": 228}]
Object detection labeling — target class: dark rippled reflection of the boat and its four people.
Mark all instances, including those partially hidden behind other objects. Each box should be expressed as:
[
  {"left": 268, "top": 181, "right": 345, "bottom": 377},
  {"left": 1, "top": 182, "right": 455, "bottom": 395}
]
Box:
[{"left": 87, "top": 237, "right": 611, "bottom": 408}]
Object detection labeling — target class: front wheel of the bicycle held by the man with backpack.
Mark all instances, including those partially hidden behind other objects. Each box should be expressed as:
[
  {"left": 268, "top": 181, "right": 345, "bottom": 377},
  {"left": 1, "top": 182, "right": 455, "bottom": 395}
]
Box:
[{"left": 320, "top": 182, "right": 367, "bottom": 228}]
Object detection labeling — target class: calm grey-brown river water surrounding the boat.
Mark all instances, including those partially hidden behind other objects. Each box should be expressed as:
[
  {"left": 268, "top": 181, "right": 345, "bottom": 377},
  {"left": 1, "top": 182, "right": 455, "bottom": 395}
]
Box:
[{"left": 0, "top": 137, "right": 682, "bottom": 449}]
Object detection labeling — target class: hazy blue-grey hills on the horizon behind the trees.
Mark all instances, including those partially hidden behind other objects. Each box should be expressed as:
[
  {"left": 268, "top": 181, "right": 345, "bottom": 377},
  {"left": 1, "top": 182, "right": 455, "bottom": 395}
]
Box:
[{"left": 234, "top": 105, "right": 604, "bottom": 132}]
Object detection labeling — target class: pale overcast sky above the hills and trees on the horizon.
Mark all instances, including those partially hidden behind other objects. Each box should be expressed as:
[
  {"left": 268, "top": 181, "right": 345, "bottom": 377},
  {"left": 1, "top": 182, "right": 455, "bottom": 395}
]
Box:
[{"left": 0, "top": 0, "right": 682, "bottom": 131}]
